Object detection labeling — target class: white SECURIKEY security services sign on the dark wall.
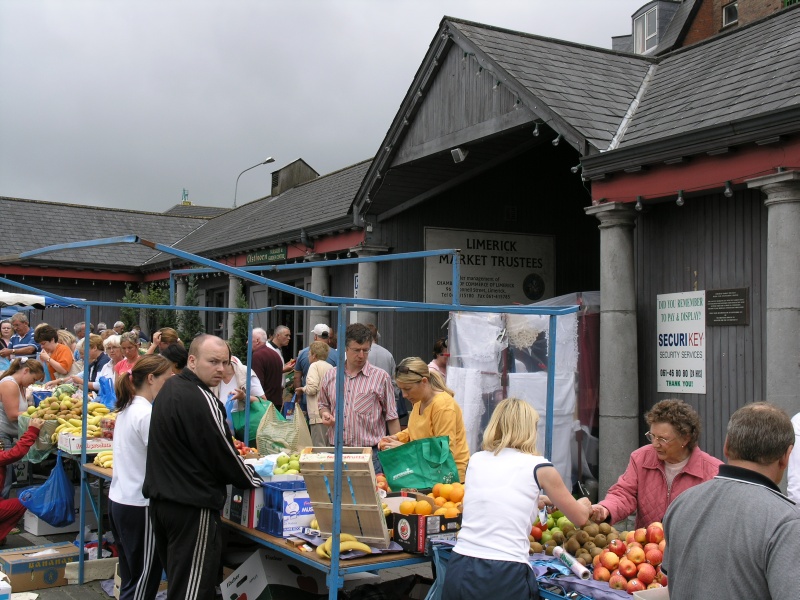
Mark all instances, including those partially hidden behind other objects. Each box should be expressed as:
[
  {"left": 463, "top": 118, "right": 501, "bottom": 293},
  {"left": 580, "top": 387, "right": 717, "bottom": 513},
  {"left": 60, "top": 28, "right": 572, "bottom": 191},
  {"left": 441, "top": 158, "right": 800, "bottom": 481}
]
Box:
[{"left": 656, "top": 291, "right": 706, "bottom": 394}]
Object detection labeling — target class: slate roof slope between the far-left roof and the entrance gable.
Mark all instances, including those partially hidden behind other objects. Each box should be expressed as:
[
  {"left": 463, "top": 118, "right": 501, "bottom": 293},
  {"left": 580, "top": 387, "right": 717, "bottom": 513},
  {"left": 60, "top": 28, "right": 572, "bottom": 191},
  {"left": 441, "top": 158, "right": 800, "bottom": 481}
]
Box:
[{"left": 166, "top": 160, "right": 370, "bottom": 256}]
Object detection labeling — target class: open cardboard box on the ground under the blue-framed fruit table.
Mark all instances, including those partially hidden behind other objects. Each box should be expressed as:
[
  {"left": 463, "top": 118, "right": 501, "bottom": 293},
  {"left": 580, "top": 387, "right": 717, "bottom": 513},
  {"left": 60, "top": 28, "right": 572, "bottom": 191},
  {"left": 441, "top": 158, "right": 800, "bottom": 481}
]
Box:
[{"left": 220, "top": 548, "right": 380, "bottom": 600}]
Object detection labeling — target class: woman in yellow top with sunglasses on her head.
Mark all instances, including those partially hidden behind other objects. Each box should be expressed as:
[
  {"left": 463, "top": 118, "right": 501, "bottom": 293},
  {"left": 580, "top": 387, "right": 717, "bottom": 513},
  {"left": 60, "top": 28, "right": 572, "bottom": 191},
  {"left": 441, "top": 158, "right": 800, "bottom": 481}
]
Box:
[{"left": 378, "top": 356, "right": 469, "bottom": 482}]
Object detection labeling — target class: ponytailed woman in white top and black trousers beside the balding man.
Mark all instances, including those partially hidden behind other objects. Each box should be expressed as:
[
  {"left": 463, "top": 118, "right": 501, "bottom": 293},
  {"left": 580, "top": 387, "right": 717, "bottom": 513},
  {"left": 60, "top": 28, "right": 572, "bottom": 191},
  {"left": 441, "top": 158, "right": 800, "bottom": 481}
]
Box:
[{"left": 108, "top": 354, "right": 172, "bottom": 600}]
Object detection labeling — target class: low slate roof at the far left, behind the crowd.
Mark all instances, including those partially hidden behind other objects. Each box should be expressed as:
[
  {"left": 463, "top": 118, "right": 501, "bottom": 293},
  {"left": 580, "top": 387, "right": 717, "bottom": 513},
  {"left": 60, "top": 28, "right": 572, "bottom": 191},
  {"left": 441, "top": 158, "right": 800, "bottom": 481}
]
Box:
[{"left": 0, "top": 197, "right": 207, "bottom": 270}]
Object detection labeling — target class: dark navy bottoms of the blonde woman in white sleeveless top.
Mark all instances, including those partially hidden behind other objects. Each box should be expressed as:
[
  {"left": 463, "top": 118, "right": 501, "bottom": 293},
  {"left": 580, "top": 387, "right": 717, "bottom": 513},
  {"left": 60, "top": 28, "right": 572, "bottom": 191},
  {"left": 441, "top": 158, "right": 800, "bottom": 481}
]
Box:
[{"left": 437, "top": 552, "right": 539, "bottom": 600}]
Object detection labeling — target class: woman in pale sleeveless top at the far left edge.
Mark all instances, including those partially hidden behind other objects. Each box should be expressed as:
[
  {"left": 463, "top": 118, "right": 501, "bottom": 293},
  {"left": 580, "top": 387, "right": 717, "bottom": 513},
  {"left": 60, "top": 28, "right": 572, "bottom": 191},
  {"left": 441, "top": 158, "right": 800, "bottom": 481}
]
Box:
[{"left": 0, "top": 357, "right": 44, "bottom": 498}]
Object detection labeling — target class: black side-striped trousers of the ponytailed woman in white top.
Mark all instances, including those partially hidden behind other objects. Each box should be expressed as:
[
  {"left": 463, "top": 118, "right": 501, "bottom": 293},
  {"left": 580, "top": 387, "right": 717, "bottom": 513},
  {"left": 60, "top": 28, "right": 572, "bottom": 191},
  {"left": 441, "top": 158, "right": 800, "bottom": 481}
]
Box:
[{"left": 108, "top": 500, "right": 162, "bottom": 600}]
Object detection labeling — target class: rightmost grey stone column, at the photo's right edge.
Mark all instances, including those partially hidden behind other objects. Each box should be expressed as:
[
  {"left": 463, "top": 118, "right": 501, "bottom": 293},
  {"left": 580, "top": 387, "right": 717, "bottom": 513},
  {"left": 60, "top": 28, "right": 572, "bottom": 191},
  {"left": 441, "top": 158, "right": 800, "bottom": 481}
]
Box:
[{"left": 747, "top": 171, "right": 800, "bottom": 417}]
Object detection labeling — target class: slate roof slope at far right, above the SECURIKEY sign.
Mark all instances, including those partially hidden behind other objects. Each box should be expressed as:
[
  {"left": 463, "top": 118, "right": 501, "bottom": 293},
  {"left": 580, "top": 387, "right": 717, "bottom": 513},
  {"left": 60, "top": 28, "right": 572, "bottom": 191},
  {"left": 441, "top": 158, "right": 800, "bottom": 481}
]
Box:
[{"left": 620, "top": 8, "right": 800, "bottom": 148}]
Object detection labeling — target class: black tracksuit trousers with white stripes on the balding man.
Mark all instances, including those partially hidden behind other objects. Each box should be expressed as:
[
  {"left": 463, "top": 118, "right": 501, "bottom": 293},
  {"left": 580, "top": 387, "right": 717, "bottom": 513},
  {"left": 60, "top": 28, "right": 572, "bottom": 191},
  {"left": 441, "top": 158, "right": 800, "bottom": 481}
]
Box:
[{"left": 150, "top": 499, "right": 222, "bottom": 600}]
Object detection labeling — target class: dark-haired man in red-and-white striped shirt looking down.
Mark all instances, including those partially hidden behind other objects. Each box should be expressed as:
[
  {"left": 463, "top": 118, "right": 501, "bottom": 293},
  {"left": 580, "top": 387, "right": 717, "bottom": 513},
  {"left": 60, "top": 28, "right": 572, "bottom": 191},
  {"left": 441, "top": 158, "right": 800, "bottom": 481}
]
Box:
[{"left": 317, "top": 323, "right": 400, "bottom": 473}]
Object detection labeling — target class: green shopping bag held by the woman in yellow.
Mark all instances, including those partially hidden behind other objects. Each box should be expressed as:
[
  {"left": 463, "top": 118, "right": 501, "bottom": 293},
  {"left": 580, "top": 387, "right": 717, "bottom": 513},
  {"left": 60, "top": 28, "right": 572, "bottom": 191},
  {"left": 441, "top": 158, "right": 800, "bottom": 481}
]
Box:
[{"left": 378, "top": 435, "right": 458, "bottom": 490}]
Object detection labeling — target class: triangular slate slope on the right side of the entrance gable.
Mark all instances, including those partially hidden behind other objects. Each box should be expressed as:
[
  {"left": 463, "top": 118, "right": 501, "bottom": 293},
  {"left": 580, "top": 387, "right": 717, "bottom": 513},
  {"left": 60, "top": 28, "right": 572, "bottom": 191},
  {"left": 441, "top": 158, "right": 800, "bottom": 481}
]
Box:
[{"left": 444, "top": 17, "right": 654, "bottom": 150}]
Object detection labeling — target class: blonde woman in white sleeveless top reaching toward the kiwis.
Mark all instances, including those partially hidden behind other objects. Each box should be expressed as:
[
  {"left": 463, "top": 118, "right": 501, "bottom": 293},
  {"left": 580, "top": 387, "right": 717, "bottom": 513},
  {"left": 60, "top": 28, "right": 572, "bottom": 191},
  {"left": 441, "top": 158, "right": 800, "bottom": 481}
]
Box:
[{"left": 442, "top": 398, "right": 592, "bottom": 600}]
